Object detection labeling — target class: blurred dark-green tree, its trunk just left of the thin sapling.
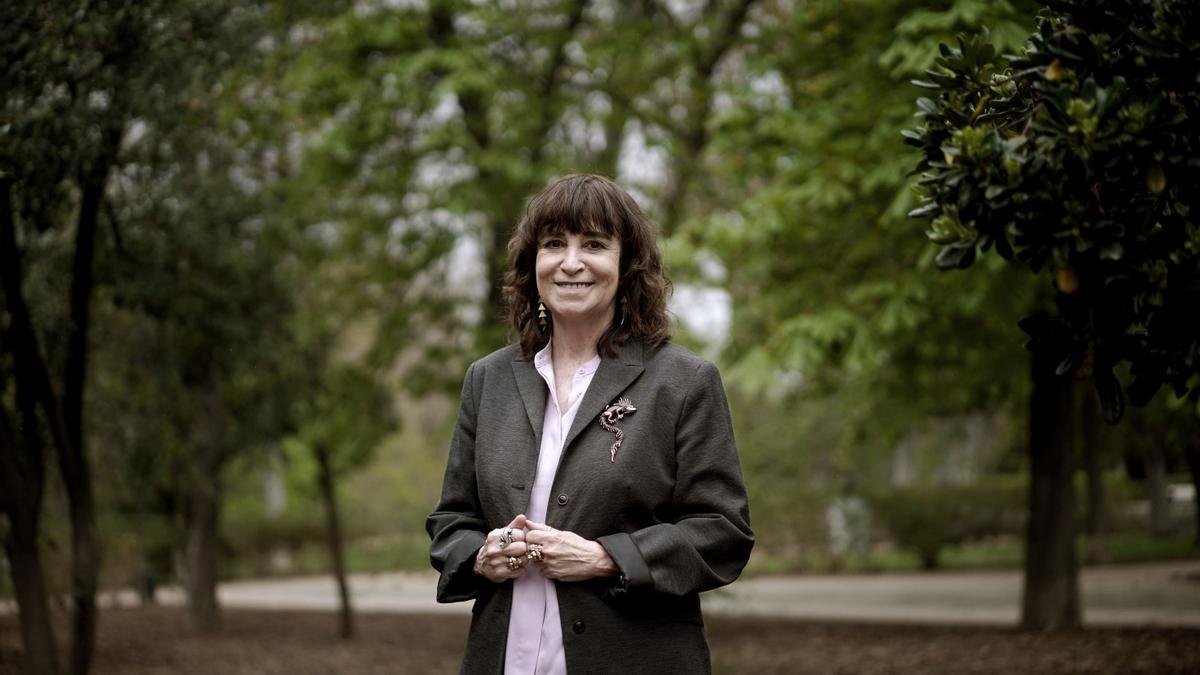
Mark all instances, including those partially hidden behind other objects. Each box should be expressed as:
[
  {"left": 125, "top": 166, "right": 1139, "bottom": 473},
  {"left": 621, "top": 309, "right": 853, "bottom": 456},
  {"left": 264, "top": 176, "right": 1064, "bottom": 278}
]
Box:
[{"left": 109, "top": 106, "right": 294, "bottom": 631}]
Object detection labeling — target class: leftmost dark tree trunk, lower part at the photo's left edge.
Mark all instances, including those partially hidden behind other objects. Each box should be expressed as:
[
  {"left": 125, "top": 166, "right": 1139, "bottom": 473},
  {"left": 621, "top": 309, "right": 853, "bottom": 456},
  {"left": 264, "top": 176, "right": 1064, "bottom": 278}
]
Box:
[{"left": 0, "top": 410, "right": 59, "bottom": 675}]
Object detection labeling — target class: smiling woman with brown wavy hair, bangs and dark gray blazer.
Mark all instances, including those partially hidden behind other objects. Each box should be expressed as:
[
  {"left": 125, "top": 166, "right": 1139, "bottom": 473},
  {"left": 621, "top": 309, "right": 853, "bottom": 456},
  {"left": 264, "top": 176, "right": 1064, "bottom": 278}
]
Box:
[{"left": 426, "top": 175, "right": 754, "bottom": 675}]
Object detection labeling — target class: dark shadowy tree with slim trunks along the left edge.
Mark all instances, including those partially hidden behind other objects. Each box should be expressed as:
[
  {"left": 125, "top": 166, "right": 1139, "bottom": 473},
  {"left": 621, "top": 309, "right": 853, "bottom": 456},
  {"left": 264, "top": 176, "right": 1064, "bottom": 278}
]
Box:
[{"left": 0, "top": 1, "right": 250, "bottom": 673}]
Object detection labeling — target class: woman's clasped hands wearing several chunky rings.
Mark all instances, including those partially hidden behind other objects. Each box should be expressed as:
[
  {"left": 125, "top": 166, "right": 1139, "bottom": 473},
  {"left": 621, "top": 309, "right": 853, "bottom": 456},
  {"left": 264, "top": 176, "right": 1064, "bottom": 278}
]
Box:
[{"left": 475, "top": 514, "right": 618, "bottom": 584}]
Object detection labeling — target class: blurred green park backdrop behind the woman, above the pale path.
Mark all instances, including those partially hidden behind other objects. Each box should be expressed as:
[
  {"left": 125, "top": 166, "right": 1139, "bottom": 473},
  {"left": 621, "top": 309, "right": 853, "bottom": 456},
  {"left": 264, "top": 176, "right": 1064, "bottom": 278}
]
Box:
[{"left": 0, "top": 0, "right": 1200, "bottom": 663}]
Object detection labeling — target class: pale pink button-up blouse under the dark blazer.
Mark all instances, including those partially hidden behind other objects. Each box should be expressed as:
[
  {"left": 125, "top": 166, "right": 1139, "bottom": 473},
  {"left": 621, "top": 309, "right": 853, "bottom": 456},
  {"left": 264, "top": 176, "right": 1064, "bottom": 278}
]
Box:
[{"left": 504, "top": 344, "right": 600, "bottom": 675}]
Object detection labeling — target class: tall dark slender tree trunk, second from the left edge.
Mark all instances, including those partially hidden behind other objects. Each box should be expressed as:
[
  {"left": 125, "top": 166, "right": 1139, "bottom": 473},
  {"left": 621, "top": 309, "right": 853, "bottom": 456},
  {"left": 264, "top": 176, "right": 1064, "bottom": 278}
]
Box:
[{"left": 59, "top": 154, "right": 115, "bottom": 675}]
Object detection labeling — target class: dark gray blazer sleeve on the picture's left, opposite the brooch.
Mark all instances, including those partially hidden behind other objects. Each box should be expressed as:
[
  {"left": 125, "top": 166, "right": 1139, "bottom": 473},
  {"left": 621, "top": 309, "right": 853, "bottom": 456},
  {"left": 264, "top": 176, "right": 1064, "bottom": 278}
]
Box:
[{"left": 425, "top": 365, "right": 488, "bottom": 603}]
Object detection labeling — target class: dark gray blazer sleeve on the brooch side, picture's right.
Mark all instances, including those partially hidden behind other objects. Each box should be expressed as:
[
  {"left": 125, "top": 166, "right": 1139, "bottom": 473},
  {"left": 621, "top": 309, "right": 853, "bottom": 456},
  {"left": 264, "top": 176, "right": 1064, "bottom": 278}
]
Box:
[{"left": 599, "top": 362, "right": 754, "bottom": 596}]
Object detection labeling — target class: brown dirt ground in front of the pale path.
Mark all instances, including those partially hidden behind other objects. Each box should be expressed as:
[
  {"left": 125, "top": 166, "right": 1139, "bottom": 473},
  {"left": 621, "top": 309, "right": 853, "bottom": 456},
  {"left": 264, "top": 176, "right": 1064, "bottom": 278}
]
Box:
[{"left": 0, "top": 608, "right": 1200, "bottom": 675}]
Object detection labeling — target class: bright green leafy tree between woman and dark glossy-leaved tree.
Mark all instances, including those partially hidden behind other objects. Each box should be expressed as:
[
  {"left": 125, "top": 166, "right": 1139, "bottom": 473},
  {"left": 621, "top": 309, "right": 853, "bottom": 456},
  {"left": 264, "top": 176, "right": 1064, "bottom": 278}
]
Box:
[{"left": 667, "top": 1, "right": 1032, "bottom": 521}]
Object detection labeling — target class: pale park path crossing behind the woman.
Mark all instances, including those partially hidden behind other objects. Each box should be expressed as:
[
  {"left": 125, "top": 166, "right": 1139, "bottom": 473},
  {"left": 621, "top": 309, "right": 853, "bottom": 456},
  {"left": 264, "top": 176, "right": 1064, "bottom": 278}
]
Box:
[{"left": 102, "top": 560, "right": 1200, "bottom": 627}]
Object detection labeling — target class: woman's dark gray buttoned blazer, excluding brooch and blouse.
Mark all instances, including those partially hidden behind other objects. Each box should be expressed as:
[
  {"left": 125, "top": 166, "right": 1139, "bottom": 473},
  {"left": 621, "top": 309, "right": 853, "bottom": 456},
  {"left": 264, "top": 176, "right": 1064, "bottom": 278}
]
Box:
[{"left": 426, "top": 342, "right": 754, "bottom": 674}]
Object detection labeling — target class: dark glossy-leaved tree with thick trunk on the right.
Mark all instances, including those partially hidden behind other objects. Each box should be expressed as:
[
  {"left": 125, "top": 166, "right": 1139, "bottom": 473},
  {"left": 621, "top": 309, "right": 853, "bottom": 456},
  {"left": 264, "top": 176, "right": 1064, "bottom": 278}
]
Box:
[{"left": 906, "top": 0, "right": 1200, "bottom": 631}]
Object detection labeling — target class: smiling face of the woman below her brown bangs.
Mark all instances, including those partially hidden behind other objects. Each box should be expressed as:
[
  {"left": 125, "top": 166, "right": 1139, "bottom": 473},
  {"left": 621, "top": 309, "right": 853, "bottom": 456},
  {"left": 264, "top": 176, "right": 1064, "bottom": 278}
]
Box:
[{"left": 535, "top": 233, "right": 620, "bottom": 328}]
